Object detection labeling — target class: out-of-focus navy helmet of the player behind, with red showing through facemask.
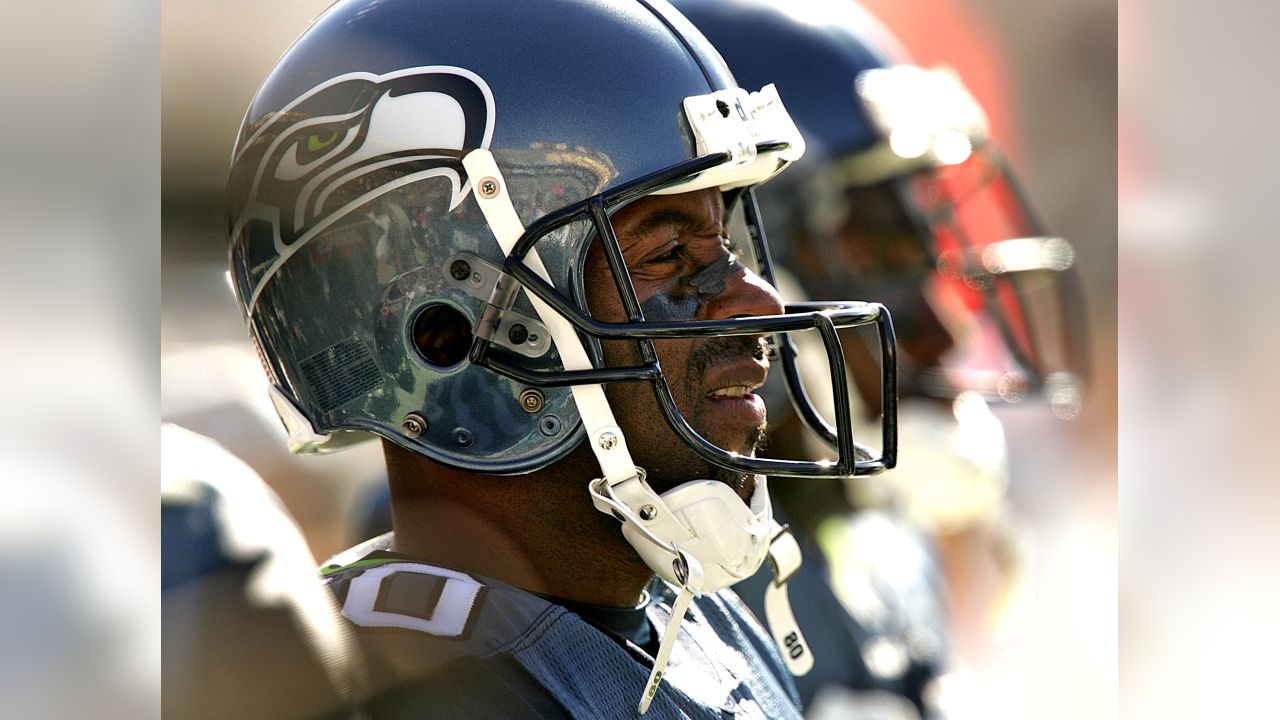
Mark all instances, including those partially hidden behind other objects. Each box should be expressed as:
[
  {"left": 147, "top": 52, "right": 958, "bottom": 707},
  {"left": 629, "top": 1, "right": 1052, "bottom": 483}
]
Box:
[{"left": 676, "top": 0, "right": 1087, "bottom": 416}]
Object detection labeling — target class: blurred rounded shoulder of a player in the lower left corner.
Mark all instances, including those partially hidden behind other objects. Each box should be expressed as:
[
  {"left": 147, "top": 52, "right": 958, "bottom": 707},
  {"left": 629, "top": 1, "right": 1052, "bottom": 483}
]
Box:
[{"left": 160, "top": 423, "right": 365, "bottom": 720}]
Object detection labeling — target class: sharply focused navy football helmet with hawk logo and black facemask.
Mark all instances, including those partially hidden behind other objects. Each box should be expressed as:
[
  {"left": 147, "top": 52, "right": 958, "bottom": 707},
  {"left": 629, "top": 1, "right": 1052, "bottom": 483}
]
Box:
[{"left": 228, "top": 0, "right": 896, "bottom": 477}]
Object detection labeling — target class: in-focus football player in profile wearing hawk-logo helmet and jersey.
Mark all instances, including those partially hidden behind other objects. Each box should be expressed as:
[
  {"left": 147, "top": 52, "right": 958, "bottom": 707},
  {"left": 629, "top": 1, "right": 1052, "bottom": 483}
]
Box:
[{"left": 228, "top": 0, "right": 896, "bottom": 719}]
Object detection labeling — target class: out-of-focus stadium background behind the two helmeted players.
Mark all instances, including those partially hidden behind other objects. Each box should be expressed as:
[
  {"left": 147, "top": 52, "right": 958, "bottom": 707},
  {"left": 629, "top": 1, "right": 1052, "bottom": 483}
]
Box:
[{"left": 160, "top": 0, "right": 1117, "bottom": 720}]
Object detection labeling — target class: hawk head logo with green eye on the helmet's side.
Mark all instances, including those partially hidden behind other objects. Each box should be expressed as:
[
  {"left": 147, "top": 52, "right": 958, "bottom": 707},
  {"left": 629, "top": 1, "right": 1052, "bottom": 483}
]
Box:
[{"left": 229, "top": 65, "right": 494, "bottom": 313}]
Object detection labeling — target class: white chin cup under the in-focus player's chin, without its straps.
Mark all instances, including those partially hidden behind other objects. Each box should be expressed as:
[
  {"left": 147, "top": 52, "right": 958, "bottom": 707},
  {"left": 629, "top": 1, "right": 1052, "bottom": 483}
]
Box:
[{"left": 622, "top": 475, "right": 773, "bottom": 594}]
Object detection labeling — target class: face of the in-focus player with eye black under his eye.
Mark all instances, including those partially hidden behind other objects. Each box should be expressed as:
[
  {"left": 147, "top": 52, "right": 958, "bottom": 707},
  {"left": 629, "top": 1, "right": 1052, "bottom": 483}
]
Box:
[{"left": 586, "top": 188, "right": 782, "bottom": 498}]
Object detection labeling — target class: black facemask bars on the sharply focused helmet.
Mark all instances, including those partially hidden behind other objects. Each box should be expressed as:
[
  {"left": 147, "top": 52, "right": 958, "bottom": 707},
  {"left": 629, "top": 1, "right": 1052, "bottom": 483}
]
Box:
[{"left": 470, "top": 142, "right": 897, "bottom": 478}]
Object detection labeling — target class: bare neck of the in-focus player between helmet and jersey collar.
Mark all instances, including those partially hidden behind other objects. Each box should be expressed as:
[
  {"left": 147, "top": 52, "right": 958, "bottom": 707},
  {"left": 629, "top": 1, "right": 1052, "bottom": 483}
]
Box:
[{"left": 387, "top": 438, "right": 652, "bottom": 607}]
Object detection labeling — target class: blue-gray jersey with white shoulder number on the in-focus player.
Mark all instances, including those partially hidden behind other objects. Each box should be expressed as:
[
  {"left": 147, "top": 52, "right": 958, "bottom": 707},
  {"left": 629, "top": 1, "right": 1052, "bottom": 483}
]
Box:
[{"left": 324, "top": 536, "right": 800, "bottom": 720}]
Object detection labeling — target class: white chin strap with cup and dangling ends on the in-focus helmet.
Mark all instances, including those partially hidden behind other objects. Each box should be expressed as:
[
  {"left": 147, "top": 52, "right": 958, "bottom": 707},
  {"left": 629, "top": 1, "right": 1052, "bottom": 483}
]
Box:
[{"left": 462, "top": 149, "right": 813, "bottom": 714}]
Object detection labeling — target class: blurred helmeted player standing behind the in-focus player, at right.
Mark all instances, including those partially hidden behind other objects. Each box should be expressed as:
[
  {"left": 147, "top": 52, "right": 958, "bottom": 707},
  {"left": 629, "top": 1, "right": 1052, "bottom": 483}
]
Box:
[{"left": 677, "top": 0, "right": 1085, "bottom": 717}]
